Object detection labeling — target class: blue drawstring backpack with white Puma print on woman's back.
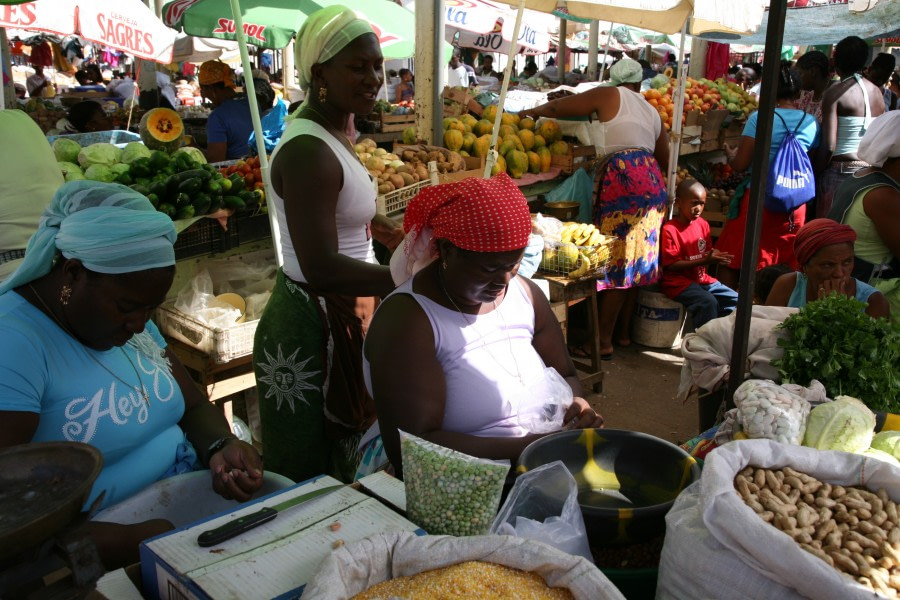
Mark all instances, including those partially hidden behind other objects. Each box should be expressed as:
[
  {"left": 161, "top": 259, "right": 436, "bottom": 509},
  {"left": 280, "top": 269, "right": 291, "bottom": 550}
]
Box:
[{"left": 765, "top": 111, "right": 816, "bottom": 213}]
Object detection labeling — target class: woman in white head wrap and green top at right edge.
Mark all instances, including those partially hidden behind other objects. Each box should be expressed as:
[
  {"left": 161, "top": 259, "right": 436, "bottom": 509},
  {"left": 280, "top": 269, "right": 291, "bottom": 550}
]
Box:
[{"left": 828, "top": 110, "right": 900, "bottom": 320}]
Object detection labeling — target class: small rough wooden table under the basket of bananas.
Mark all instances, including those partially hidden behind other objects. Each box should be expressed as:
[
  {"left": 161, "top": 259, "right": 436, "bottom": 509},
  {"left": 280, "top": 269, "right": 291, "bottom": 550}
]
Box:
[{"left": 535, "top": 272, "right": 603, "bottom": 393}]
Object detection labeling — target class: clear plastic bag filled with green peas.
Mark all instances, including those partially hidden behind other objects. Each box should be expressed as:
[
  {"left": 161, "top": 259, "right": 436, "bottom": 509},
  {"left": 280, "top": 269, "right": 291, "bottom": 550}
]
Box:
[{"left": 400, "top": 431, "right": 510, "bottom": 536}]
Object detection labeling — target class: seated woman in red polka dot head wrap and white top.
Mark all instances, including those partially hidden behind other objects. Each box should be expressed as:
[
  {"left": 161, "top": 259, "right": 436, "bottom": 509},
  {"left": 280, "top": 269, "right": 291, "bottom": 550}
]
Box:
[{"left": 363, "top": 174, "right": 603, "bottom": 476}]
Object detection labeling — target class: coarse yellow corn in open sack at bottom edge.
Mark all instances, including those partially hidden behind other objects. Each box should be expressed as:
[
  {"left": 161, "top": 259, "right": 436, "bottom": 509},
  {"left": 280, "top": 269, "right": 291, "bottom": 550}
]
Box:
[{"left": 351, "top": 561, "right": 572, "bottom": 600}]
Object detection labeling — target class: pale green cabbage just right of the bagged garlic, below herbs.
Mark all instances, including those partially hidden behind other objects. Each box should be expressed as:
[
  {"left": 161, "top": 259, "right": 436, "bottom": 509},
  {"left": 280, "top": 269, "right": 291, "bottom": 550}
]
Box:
[{"left": 803, "top": 396, "right": 875, "bottom": 453}]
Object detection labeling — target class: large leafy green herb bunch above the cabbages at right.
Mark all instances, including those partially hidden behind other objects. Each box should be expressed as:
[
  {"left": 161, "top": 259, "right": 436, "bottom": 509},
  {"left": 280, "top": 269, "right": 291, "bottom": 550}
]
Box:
[{"left": 772, "top": 293, "right": 900, "bottom": 413}]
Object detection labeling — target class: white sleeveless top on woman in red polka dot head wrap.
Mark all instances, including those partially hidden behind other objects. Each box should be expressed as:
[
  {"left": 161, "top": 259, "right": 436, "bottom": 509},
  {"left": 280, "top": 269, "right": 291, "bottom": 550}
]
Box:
[{"left": 363, "top": 277, "right": 544, "bottom": 440}]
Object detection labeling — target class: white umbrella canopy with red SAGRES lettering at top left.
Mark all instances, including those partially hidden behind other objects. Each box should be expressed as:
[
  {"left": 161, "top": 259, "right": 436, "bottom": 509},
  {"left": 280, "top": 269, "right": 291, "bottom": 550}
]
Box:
[{"left": 0, "top": 0, "right": 175, "bottom": 64}]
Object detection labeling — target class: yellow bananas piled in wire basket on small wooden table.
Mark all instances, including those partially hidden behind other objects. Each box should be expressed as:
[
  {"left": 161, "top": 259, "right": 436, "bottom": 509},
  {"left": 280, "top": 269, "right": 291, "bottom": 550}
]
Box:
[{"left": 540, "top": 221, "right": 614, "bottom": 279}]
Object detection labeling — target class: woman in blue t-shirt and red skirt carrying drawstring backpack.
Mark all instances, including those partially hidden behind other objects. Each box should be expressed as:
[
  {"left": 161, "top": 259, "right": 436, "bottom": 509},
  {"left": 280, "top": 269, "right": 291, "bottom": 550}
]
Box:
[{"left": 716, "top": 61, "right": 819, "bottom": 289}]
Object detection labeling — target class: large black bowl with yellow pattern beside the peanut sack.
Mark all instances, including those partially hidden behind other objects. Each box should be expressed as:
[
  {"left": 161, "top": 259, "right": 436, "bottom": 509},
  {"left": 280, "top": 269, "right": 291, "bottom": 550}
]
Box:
[{"left": 518, "top": 429, "right": 700, "bottom": 546}]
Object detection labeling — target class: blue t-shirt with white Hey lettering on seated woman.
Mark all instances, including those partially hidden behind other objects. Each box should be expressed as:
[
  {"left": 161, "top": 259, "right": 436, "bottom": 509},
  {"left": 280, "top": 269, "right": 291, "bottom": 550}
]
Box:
[{"left": 0, "top": 292, "right": 190, "bottom": 508}]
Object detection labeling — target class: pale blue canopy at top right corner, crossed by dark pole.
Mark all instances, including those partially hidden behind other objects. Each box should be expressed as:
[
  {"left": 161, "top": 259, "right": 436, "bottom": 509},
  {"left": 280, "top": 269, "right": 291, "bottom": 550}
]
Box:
[{"left": 701, "top": 0, "right": 900, "bottom": 46}]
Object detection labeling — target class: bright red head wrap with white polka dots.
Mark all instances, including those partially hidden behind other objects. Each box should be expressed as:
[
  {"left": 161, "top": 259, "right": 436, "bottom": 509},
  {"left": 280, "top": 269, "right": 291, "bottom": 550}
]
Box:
[{"left": 403, "top": 173, "right": 531, "bottom": 252}]
